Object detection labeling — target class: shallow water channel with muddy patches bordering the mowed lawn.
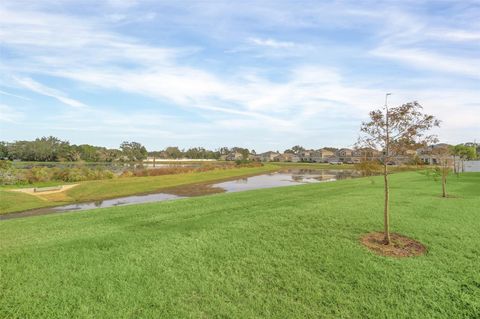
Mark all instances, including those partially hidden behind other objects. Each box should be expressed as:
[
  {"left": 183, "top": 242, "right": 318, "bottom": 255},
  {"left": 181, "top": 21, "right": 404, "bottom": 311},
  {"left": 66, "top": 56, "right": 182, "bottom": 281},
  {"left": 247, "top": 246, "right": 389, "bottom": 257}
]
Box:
[{"left": 0, "top": 169, "right": 360, "bottom": 220}]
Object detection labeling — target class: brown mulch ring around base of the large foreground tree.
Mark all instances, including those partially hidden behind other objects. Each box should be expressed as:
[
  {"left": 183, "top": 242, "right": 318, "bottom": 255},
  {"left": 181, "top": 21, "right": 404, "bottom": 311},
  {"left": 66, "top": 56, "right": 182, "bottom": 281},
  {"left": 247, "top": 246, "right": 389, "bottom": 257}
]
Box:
[{"left": 360, "top": 232, "right": 427, "bottom": 258}]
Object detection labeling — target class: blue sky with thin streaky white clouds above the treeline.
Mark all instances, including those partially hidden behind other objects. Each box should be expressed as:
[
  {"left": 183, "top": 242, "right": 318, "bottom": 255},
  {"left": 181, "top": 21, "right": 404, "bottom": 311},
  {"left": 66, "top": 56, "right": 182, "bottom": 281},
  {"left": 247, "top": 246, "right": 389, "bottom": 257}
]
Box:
[{"left": 0, "top": 0, "right": 480, "bottom": 152}]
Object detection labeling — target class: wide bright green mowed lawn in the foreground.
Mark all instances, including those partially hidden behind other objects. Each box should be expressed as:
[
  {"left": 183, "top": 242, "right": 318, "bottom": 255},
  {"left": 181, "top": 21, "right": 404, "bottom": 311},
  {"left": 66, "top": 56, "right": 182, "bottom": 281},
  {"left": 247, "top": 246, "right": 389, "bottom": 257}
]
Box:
[{"left": 0, "top": 172, "right": 480, "bottom": 318}]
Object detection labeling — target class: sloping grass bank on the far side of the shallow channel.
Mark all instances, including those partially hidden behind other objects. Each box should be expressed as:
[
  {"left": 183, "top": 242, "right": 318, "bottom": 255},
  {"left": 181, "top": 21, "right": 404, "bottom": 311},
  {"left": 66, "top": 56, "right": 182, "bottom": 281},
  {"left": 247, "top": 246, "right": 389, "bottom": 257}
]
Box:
[{"left": 0, "top": 165, "right": 278, "bottom": 214}]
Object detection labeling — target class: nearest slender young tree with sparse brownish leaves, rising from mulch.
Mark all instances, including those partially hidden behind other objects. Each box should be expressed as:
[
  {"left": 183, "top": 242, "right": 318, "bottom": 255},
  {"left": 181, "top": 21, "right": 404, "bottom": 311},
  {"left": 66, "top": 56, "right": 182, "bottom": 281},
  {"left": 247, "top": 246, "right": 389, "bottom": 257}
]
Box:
[{"left": 357, "top": 97, "right": 440, "bottom": 245}]
